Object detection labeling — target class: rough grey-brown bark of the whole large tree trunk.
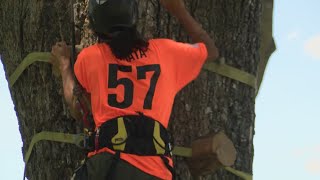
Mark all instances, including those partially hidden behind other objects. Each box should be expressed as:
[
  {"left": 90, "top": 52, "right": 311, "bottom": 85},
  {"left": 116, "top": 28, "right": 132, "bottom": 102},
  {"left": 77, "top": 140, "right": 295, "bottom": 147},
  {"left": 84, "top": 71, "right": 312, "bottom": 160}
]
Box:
[{"left": 0, "top": 0, "right": 262, "bottom": 180}]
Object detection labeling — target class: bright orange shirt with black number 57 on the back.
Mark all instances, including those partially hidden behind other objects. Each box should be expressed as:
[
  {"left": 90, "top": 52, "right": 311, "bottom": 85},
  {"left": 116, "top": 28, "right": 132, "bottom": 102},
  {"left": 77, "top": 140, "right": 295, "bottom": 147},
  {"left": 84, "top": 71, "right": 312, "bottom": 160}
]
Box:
[{"left": 74, "top": 39, "right": 207, "bottom": 179}]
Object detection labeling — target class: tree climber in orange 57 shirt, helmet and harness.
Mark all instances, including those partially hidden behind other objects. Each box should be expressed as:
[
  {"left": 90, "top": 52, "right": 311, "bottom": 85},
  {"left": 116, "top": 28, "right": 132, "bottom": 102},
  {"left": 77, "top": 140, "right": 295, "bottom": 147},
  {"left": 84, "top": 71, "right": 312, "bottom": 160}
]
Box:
[{"left": 52, "top": 0, "right": 218, "bottom": 180}]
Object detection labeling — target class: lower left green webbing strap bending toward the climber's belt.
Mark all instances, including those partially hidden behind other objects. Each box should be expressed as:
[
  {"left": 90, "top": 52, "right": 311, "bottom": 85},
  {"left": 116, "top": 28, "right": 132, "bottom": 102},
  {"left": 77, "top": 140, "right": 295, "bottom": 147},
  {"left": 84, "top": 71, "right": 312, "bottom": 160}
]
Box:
[{"left": 24, "top": 131, "right": 84, "bottom": 165}]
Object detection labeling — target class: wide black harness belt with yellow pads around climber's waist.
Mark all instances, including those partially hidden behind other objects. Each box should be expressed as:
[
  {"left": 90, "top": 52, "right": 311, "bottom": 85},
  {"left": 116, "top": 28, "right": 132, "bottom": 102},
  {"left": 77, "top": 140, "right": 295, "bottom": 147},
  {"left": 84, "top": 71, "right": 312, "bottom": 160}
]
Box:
[{"left": 95, "top": 115, "right": 171, "bottom": 156}]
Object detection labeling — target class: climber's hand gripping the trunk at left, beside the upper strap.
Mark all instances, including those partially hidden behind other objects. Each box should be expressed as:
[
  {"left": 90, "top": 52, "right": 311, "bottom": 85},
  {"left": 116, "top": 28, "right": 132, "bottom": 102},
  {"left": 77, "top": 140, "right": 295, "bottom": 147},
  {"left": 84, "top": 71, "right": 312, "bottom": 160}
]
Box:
[{"left": 51, "top": 42, "right": 71, "bottom": 71}]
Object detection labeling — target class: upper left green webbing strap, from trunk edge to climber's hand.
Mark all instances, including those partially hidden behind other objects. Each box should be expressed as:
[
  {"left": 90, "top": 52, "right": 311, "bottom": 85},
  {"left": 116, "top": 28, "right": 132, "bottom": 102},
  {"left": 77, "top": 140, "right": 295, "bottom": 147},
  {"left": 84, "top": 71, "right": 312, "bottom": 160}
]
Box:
[{"left": 9, "top": 52, "right": 51, "bottom": 87}]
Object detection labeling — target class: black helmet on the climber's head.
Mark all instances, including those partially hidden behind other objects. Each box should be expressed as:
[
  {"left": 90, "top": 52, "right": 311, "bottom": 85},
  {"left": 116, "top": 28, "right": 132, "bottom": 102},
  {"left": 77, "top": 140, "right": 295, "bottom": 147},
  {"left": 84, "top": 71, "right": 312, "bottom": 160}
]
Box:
[{"left": 89, "top": 0, "right": 137, "bottom": 33}]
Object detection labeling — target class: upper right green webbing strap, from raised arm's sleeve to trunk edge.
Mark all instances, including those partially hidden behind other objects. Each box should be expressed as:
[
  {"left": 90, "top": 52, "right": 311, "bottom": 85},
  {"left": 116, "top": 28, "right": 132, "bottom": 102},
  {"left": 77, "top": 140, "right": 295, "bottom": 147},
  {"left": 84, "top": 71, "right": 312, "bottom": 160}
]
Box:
[{"left": 203, "top": 60, "right": 257, "bottom": 89}]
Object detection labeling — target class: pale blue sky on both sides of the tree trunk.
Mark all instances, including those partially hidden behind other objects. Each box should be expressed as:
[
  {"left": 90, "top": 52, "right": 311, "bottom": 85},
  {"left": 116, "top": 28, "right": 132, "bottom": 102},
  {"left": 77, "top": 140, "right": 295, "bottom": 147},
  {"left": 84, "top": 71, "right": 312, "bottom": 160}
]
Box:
[{"left": 0, "top": 0, "right": 320, "bottom": 180}]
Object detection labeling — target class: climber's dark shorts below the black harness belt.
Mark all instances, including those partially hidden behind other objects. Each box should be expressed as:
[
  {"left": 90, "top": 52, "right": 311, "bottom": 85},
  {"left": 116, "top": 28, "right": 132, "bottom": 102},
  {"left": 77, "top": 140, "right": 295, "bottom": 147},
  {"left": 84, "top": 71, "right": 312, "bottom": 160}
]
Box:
[{"left": 73, "top": 153, "right": 159, "bottom": 180}]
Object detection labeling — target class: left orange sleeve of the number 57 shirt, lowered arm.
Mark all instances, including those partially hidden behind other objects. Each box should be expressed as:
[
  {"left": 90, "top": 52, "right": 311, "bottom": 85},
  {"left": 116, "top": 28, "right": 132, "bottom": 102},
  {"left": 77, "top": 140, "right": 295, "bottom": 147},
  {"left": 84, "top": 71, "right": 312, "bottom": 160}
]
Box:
[{"left": 74, "top": 52, "right": 91, "bottom": 93}]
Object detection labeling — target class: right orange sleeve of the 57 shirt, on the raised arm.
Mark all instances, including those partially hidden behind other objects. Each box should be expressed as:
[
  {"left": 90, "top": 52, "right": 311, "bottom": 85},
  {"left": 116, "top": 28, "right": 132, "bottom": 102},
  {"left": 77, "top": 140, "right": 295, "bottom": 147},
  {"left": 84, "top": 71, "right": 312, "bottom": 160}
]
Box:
[{"left": 155, "top": 39, "right": 208, "bottom": 91}]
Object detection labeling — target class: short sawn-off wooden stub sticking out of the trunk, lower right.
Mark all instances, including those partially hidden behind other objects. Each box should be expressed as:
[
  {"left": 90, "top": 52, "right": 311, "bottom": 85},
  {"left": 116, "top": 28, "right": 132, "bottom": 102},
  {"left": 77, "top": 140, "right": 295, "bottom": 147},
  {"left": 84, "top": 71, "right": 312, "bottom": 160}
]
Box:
[{"left": 188, "top": 132, "right": 237, "bottom": 176}]
